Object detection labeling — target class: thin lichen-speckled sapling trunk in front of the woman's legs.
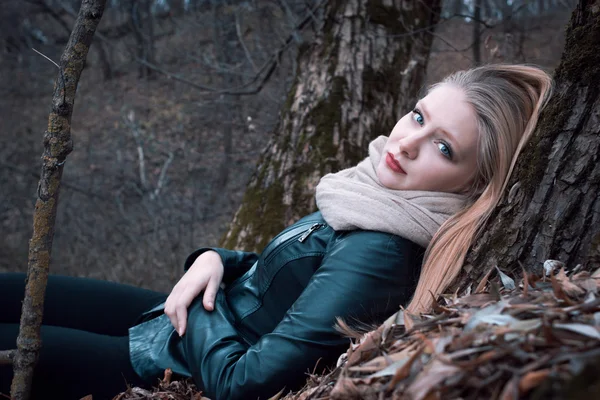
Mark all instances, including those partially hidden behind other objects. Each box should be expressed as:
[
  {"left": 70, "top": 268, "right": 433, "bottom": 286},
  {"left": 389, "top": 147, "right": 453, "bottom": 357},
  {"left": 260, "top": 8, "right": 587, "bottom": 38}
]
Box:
[{"left": 9, "top": 0, "right": 106, "bottom": 400}]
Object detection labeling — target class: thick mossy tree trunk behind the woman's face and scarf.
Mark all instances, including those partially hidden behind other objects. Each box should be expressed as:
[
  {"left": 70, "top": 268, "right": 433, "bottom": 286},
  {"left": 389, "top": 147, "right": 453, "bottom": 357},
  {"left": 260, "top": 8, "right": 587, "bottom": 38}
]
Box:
[{"left": 223, "top": 0, "right": 440, "bottom": 250}]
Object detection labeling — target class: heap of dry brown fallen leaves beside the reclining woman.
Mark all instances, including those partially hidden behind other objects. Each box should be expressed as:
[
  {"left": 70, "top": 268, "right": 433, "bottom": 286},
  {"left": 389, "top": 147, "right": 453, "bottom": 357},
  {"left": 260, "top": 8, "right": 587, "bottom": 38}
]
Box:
[{"left": 285, "top": 263, "right": 600, "bottom": 400}]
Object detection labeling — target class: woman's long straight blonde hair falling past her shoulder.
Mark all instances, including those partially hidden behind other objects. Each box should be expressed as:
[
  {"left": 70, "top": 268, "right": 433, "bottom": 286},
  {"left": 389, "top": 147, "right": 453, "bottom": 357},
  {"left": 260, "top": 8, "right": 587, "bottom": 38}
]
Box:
[{"left": 407, "top": 64, "right": 553, "bottom": 314}]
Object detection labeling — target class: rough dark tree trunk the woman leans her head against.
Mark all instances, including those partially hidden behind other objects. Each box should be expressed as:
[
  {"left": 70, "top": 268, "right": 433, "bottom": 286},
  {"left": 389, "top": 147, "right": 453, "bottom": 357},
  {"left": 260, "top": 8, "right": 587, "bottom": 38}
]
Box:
[{"left": 455, "top": 0, "right": 600, "bottom": 288}]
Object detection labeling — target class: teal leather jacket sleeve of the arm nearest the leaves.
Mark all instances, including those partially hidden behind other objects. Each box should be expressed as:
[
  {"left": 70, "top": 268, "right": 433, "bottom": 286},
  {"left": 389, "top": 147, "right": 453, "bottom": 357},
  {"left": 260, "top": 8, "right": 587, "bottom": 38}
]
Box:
[{"left": 183, "top": 231, "right": 419, "bottom": 400}]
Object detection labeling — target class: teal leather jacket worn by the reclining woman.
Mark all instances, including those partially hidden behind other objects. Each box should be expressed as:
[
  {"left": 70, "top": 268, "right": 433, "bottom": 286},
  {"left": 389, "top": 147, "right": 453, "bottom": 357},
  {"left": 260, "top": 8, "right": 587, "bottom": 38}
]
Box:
[{"left": 130, "top": 212, "right": 423, "bottom": 400}]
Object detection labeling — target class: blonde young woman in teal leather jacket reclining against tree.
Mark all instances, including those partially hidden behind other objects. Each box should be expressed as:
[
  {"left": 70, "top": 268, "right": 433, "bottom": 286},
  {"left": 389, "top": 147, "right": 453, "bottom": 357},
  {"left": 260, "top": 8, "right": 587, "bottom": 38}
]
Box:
[{"left": 0, "top": 65, "right": 552, "bottom": 400}]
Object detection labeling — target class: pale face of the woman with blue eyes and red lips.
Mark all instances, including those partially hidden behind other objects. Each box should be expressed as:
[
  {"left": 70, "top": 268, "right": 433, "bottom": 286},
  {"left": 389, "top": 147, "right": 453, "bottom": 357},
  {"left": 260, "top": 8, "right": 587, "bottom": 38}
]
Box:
[{"left": 377, "top": 84, "right": 478, "bottom": 193}]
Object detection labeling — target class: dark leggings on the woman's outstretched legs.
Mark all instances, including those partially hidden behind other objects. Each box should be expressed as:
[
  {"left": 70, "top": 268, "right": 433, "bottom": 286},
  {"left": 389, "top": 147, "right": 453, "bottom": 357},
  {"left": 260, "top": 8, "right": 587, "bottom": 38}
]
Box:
[{"left": 0, "top": 273, "right": 167, "bottom": 400}]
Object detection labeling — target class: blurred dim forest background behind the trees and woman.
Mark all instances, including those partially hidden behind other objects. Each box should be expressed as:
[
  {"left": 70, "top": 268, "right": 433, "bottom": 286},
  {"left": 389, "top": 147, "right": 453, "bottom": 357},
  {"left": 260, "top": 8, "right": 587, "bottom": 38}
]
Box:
[{"left": 0, "top": 0, "right": 575, "bottom": 292}]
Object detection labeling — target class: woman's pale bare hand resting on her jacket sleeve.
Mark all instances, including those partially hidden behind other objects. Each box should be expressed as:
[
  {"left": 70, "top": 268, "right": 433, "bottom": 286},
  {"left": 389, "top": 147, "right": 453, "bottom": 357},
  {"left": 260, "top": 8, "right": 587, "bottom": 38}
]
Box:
[{"left": 165, "top": 250, "right": 224, "bottom": 336}]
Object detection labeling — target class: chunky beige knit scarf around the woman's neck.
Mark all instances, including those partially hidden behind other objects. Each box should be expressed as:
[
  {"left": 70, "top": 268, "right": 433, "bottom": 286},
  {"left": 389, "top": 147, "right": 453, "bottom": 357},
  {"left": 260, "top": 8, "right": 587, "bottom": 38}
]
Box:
[{"left": 316, "top": 136, "right": 466, "bottom": 247}]
